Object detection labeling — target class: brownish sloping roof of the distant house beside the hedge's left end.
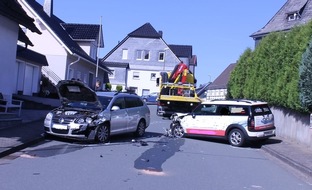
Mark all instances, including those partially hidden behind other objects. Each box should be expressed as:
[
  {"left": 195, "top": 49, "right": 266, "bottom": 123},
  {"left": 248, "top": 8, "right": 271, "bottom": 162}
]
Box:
[{"left": 208, "top": 63, "right": 236, "bottom": 90}]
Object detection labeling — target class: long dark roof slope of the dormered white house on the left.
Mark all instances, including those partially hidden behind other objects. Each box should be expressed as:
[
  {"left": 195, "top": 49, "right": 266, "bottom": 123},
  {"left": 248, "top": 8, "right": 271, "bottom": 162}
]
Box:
[{"left": 25, "top": 0, "right": 109, "bottom": 71}]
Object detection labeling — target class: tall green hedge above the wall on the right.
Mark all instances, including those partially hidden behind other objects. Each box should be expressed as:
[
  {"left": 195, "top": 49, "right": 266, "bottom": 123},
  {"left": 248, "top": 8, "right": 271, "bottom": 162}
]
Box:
[{"left": 228, "top": 22, "right": 312, "bottom": 112}]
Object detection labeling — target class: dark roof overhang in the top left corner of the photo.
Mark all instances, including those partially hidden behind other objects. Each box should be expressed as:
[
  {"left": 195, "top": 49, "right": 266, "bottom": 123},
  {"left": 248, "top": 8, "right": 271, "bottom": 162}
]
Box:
[{"left": 0, "top": 0, "right": 41, "bottom": 34}]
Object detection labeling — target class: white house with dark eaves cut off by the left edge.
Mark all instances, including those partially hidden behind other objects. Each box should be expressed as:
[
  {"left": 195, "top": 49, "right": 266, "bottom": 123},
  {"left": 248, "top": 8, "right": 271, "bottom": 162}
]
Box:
[{"left": 0, "top": 0, "right": 43, "bottom": 98}]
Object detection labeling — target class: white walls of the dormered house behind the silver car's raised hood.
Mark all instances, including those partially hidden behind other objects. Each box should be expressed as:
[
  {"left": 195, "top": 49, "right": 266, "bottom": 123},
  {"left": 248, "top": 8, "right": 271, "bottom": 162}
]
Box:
[{"left": 18, "top": 0, "right": 106, "bottom": 87}]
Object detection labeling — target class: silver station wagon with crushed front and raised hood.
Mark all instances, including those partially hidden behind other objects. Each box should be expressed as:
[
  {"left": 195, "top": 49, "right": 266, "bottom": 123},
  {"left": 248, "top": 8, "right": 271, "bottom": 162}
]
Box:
[{"left": 44, "top": 80, "right": 150, "bottom": 143}]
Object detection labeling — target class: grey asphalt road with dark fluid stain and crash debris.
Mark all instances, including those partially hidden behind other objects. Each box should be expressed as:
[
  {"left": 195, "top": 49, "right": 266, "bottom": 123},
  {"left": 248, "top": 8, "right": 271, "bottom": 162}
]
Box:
[{"left": 0, "top": 106, "right": 312, "bottom": 190}]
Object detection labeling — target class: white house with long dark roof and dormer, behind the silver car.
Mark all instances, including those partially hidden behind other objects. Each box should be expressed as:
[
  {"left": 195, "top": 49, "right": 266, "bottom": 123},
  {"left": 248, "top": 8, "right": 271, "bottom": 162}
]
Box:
[{"left": 18, "top": 0, "right": 110, "bottom": 91}]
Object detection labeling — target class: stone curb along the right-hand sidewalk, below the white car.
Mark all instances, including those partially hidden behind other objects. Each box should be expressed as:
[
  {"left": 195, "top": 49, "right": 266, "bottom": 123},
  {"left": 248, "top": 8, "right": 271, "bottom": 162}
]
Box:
[{"left": 263, "top": 146, "right": 312, "bottom": 176}]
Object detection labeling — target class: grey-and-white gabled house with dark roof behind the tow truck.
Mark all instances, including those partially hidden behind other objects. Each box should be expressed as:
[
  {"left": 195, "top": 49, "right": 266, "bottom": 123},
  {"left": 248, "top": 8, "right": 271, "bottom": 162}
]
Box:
[{"left": 101, "top": 23, "right": 197, "bottom": 95}]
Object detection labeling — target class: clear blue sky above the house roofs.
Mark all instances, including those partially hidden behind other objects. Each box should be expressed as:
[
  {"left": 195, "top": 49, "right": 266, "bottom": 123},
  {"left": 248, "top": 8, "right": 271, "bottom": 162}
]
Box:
[{"left": 37, "top": 0, "right": 287, "bottom": 85}]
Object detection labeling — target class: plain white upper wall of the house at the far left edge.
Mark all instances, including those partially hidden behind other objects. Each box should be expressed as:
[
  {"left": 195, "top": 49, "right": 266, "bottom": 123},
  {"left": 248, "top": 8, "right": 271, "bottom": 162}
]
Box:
[{"left": 0, "top": 15, "right": 19, "bottom": 95}]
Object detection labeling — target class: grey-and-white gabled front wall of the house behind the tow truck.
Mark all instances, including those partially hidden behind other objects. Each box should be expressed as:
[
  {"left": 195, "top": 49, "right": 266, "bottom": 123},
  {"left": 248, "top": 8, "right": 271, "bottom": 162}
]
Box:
[{"left": 105, "top": 37, "right": 180, "bottom": 95}]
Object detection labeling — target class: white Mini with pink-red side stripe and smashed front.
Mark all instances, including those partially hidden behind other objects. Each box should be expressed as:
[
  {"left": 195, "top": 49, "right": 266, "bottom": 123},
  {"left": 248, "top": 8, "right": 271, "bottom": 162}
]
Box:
[{"left": 170, "top": 100, "right": 276, "bottom": 146}]
